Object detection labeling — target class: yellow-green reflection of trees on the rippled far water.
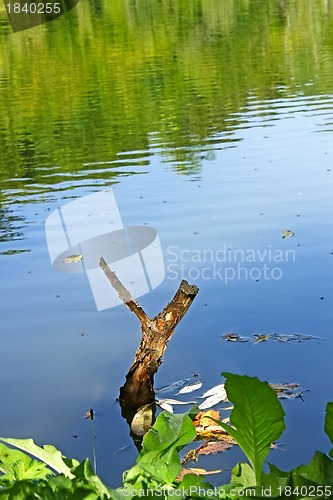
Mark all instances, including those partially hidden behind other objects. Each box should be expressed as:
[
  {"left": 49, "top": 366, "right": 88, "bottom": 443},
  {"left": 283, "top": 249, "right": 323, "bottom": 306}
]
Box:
[{"left": 0, "top": 0, "right": 333, "bottom": 191}]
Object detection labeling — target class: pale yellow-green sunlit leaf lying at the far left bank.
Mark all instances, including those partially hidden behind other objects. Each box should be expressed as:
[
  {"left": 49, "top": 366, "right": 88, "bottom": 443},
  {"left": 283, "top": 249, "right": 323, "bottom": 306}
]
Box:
[{"left": 0, "top": 437, "right": 79, "bottom": 477}]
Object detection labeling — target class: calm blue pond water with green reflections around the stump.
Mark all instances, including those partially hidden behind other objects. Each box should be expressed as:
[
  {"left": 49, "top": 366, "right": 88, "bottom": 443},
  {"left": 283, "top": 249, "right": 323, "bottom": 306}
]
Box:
[{"left": 0, "top": 0, "right": 333, "bottom": 486}]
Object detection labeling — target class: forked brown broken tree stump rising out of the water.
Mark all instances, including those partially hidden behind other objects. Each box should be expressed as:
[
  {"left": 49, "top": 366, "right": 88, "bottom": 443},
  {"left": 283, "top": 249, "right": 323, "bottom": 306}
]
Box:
[{"left": 100, "top": 257, "right": 199, "bottom": 440}]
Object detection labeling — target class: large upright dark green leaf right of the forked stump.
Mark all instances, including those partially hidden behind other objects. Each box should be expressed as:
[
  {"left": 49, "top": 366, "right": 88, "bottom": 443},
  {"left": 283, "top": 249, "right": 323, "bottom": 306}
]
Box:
[{"left": 219, "top": 373, "right": 285, "bottom": 486}]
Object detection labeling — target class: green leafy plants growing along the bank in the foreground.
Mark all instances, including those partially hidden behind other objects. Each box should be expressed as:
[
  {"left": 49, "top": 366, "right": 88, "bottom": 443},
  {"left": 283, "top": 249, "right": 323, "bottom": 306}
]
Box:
[{"left": 0, "top": 373, "right": 333, "bottom": 500}]
